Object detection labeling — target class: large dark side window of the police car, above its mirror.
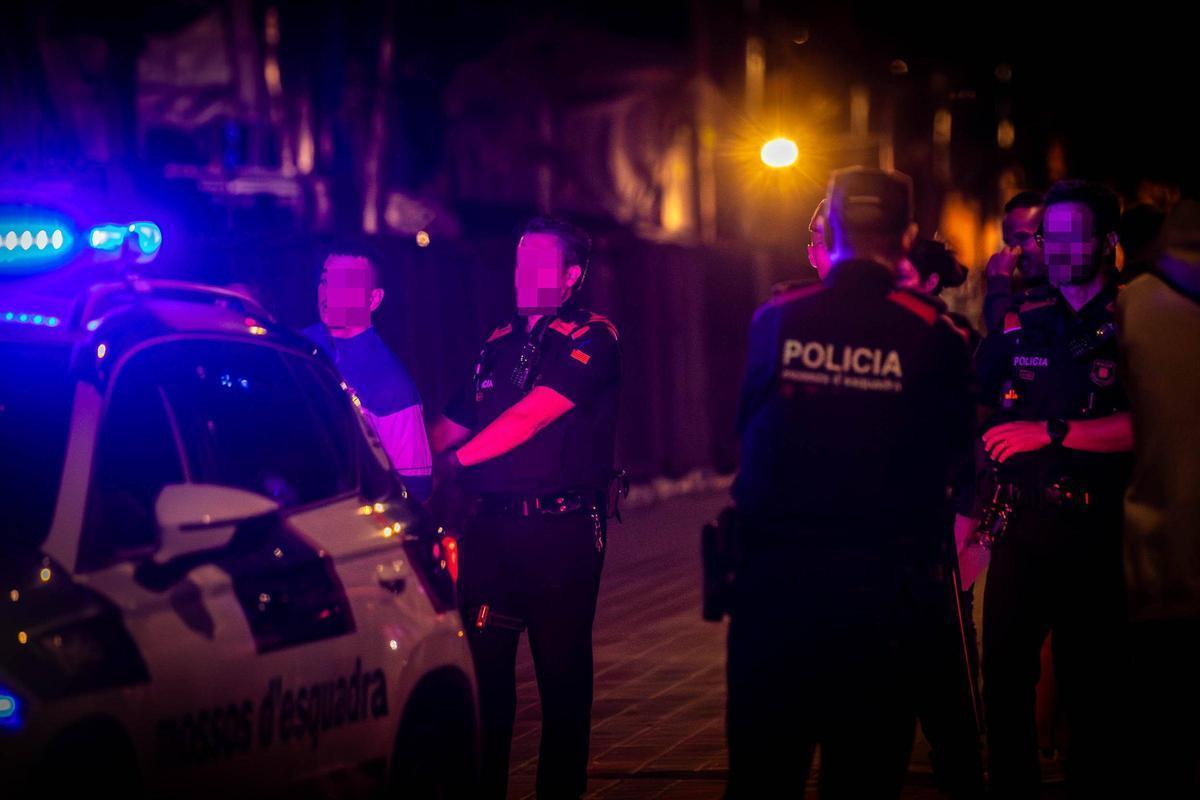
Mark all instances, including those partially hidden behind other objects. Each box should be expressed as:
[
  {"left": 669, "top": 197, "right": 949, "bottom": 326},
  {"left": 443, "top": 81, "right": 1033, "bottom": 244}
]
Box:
[{"left": 143, "top": 342, "right": 358, "bottom": 507}]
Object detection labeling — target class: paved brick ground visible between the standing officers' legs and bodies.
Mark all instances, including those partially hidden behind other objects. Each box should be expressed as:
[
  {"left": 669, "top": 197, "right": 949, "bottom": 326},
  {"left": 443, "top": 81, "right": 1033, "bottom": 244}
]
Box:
[{"left": 509, "top": 493, "right": 1051, "bottom": 800}]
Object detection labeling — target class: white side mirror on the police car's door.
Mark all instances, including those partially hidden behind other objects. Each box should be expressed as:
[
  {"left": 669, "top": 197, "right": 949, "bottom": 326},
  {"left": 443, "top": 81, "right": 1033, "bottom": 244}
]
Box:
[{"left": 154, "top": 483, "right": 280, "bottom": 564}]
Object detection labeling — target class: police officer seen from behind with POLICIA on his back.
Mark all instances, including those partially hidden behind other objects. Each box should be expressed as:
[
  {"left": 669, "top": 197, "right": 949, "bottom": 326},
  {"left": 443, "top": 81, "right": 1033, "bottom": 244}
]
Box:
[{"left": 727, "top": 168, "right": 973, "bottom": 798}]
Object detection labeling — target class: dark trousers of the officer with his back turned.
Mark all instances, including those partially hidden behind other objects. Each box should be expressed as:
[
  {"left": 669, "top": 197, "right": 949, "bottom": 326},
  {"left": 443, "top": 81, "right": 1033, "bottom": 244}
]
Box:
[{"left": 727, "top": 546, "right": 916, "bottom": 800}]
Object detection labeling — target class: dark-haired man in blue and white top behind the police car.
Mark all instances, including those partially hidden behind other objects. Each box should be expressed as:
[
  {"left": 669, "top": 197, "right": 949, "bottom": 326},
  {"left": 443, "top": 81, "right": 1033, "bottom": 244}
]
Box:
[{"left": 304, "top": 253, "right": 433, "bottom": 501}]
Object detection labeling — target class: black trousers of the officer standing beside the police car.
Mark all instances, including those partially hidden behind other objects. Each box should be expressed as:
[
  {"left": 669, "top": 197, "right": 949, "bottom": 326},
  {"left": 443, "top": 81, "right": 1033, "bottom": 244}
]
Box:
[{"left": 458, "top": 511, "right": 605, "bottom": 798}]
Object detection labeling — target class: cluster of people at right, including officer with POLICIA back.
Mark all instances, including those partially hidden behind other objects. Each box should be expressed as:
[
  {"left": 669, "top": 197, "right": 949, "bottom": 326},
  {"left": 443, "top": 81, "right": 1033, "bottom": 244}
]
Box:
[{"left": 724, "top": 168, "right": 1200, "bottom": 798}]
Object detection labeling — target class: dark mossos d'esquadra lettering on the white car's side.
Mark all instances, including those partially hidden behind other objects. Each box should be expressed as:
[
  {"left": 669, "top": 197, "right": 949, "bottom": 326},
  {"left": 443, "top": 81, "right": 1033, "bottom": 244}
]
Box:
[{"left": 155, "top": 658, "right": 388, "bottom": 764}]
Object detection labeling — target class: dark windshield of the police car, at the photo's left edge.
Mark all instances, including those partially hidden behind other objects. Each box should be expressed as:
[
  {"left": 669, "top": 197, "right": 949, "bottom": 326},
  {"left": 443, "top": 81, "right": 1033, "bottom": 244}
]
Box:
[{"left": 0, "top": 342, "right": 72, "bottom": 552}]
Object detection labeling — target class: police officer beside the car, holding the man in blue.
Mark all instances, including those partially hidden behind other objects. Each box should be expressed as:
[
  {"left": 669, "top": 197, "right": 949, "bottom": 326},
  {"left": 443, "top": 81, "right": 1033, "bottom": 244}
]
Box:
[{"left": 433, "top": 218, "right": 620, "bottom": 798}]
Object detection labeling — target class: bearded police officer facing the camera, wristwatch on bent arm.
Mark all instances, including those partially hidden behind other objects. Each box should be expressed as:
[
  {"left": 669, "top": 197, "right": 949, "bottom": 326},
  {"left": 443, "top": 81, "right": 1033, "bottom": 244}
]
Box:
[{"left": 979, "top": 181, "right": 1133, "bottom": 796}]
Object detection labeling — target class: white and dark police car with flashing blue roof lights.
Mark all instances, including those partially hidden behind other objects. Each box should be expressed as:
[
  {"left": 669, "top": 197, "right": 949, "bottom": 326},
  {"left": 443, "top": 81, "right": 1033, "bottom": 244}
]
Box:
[{"left": 0, "top": 209, "right": 478, "bottom": 796}]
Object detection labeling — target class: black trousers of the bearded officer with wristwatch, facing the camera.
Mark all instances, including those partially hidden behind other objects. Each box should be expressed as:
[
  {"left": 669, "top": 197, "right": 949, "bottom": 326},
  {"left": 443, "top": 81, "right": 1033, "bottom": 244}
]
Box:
[{"left": 983, "top": 506, "right": 1129, "bottom": 798}]
